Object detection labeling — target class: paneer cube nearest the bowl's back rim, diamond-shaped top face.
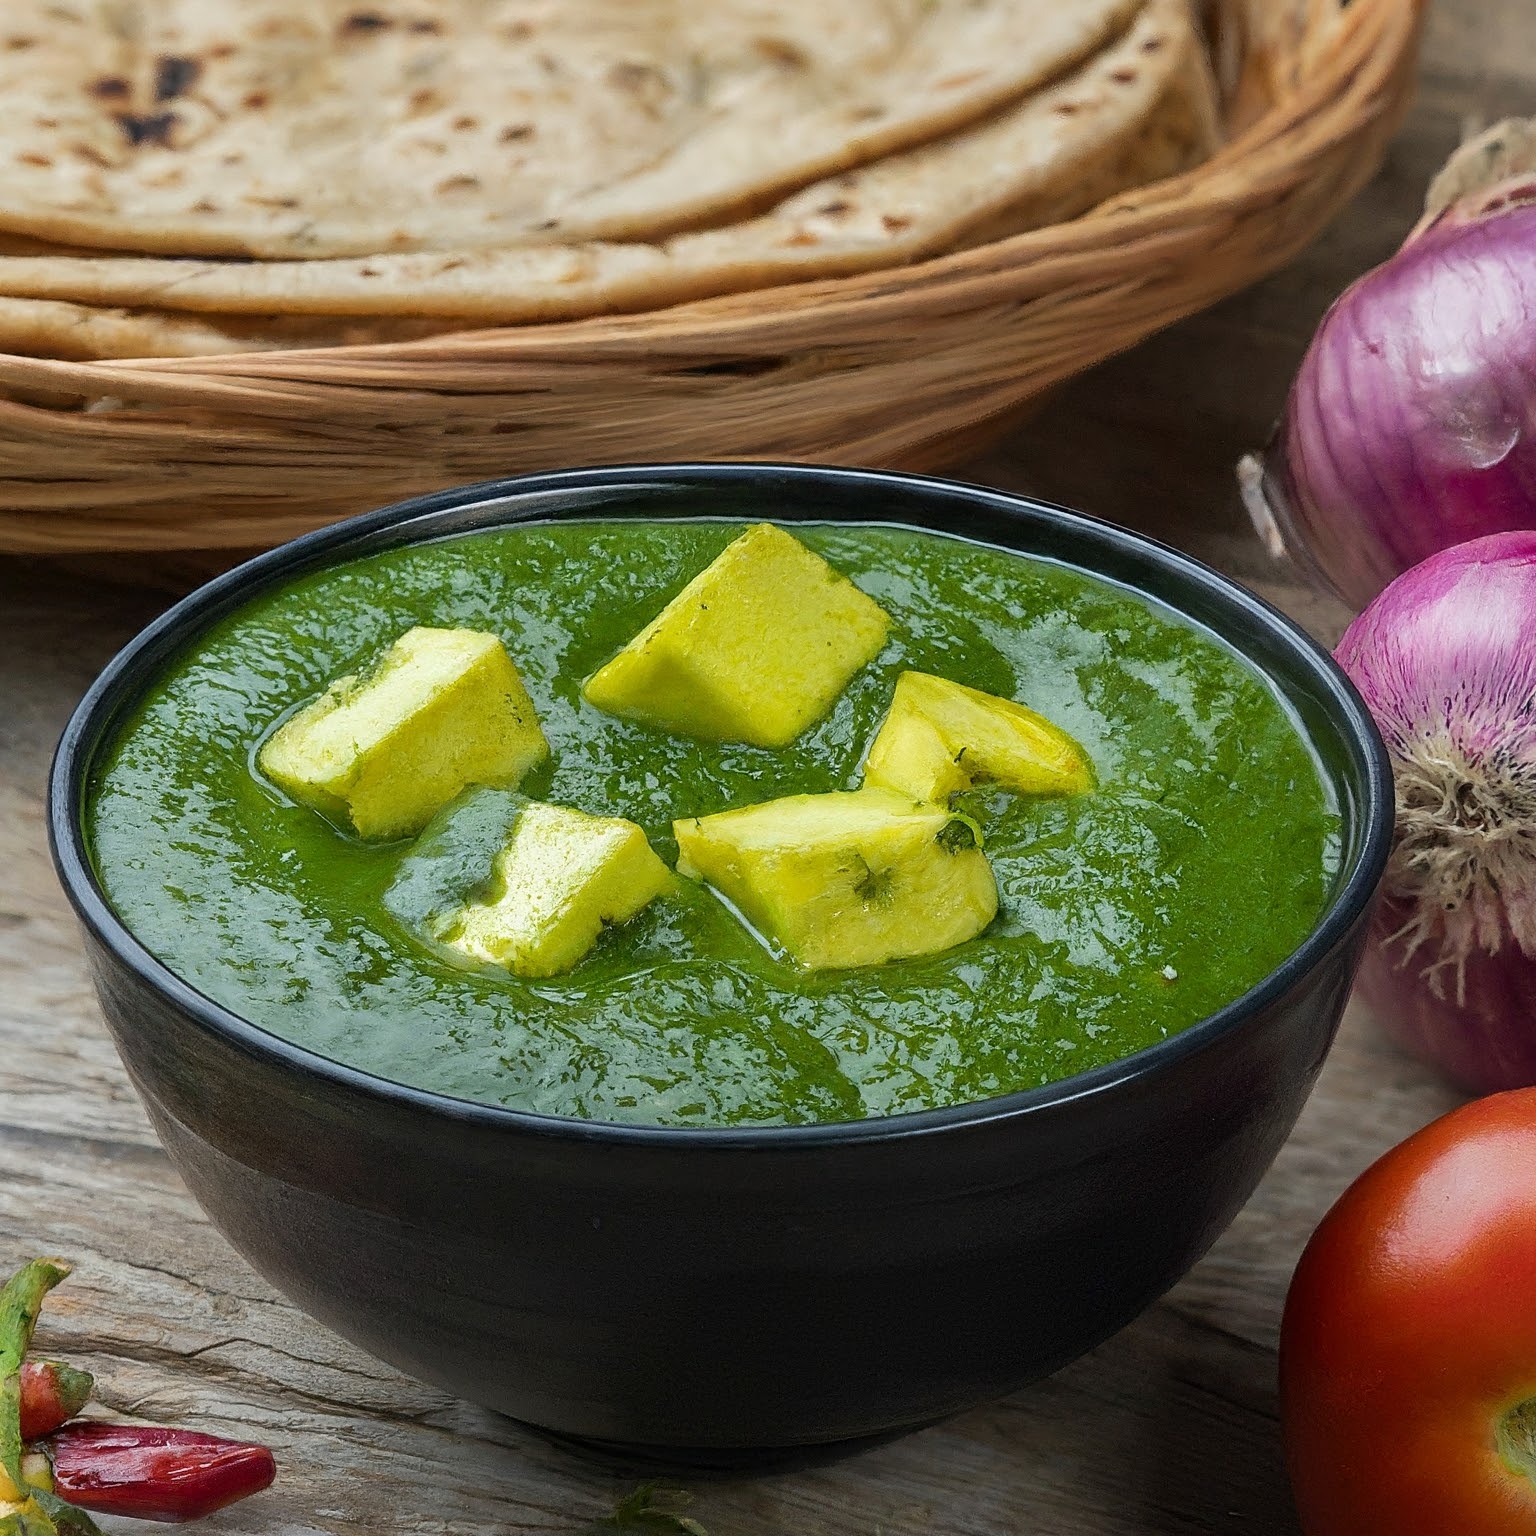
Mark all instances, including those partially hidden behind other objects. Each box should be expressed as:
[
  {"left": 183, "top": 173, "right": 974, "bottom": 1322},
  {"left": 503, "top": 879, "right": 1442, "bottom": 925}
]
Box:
[{"left": 582, "top": 522, "right": 891, "bottom": 746}]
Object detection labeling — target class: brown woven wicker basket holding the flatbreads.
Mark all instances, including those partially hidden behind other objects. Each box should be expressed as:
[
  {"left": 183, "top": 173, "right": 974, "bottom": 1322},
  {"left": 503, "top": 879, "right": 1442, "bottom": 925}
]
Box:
[{"left": 0, "top": 0, "right": 1425, "bottom": 551}]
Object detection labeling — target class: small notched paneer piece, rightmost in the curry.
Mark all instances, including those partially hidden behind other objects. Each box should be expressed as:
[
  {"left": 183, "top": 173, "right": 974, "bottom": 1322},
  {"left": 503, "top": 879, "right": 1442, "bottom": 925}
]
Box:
[{"left": 863, "top": 671, "right": 1094, "bottom": 803}]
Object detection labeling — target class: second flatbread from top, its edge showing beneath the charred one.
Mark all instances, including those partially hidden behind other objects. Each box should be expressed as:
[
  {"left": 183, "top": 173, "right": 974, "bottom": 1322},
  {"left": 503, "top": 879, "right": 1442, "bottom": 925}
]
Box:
[{"left": 0, "top": 0, "right": 1220, "bottom": 326}]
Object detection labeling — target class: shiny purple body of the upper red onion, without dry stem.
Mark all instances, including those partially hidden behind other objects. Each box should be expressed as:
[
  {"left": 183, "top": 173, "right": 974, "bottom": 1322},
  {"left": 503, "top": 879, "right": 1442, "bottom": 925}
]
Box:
[{"left": 1266, "top": 203, "right": 1536, "bottom": 608}]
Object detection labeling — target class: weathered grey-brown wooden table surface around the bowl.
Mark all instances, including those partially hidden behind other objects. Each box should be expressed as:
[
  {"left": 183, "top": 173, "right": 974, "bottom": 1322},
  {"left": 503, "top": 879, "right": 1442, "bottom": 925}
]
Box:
[{"left": 0, "top": 0, "right": 1536, "bottom": 1536}]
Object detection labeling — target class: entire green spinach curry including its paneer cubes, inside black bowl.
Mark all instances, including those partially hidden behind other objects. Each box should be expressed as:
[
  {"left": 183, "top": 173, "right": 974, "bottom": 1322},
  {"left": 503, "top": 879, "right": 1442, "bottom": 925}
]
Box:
[{"left": 88, "top": 518, "right": 1339, "bottom": 1126}]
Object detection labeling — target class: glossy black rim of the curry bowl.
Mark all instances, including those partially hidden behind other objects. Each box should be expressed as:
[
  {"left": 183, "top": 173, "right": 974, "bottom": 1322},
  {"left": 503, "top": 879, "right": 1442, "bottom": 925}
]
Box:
[{"left": 48, "top": 461, "right": 1393, "bottom": 1150}]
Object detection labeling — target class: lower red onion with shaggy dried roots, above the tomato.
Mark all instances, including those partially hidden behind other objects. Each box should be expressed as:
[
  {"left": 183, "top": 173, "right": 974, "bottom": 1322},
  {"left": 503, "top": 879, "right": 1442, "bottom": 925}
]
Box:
[{"left": 1336, "top": 531, "right": 1536, "bottom": 1094}]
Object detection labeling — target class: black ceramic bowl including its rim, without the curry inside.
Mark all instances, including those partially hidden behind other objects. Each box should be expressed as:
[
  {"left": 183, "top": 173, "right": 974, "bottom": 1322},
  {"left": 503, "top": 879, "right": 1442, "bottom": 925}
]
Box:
[{"left": 49, "top": 465, "right": 1392, "bottom": 1461}]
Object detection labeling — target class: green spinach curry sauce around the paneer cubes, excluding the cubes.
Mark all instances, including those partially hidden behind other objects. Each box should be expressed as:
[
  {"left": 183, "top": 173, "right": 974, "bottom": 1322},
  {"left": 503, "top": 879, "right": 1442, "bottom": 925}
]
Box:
[{"left": 88, "top": 519, "right": 1339, "bottom": 1126}]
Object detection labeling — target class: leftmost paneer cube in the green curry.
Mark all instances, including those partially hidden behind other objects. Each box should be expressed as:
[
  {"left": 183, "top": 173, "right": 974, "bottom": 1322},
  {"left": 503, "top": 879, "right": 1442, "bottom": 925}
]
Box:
[{"left": 258, "top": 628, "right": 550, "bottom": 839}]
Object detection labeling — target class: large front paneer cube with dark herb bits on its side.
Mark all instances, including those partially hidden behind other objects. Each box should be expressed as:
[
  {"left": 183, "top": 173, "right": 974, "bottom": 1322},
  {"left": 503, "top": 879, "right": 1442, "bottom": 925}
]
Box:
[{"left": 673, "top": 790, "right": 997, "bottom": 971}]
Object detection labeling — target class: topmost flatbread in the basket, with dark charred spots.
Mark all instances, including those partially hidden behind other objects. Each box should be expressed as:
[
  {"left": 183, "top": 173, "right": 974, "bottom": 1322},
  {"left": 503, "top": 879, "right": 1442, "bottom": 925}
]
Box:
[{"left": 0, "top": 0, "right": 1141, "bottom": 258}]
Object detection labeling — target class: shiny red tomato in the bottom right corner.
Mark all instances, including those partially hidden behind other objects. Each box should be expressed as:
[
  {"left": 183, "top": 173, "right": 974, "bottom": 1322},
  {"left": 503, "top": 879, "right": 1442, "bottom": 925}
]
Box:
[{"left": 1279, "top": 1087, "right": 1536, "bottom": 1536}]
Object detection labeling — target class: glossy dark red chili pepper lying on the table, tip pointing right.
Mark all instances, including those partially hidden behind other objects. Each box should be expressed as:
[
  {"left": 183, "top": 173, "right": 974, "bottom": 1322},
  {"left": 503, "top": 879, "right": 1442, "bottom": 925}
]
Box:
[{"left": 43, "top": 1424, "right": 276, "bottom": 1521}]
